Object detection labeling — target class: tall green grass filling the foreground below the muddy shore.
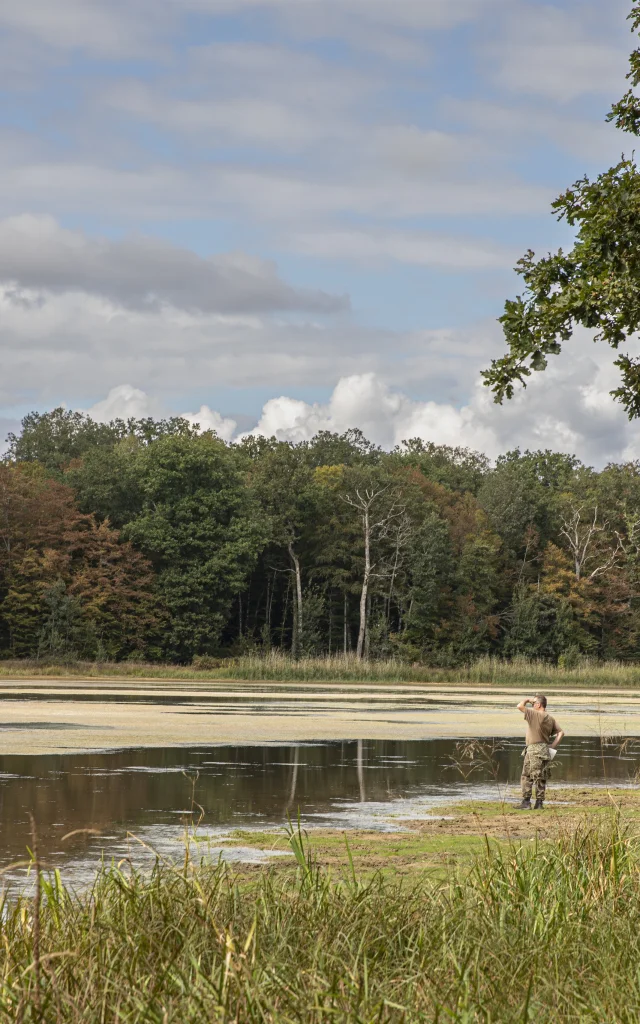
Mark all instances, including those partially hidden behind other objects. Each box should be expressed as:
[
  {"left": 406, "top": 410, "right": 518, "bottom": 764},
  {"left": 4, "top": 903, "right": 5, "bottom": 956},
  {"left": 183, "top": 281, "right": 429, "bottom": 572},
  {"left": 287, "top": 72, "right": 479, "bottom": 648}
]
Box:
[{"left": 0, "top": 818, "right": 640, "bottom": 1024}]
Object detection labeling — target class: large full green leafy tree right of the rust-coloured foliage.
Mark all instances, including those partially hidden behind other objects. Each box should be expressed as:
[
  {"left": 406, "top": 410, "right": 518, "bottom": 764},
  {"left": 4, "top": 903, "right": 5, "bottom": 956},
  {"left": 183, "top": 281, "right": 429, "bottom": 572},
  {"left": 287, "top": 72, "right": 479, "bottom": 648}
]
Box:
[{"left": 123, "top": 432, "right": 267, "bottom": 659}]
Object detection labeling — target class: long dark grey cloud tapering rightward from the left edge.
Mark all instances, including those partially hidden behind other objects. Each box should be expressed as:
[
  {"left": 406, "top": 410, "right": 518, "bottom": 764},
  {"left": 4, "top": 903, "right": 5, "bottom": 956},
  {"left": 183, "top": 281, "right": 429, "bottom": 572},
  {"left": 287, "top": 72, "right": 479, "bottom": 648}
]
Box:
[{"left": 0, "top": 215, "right": 348, "bottom": 312}]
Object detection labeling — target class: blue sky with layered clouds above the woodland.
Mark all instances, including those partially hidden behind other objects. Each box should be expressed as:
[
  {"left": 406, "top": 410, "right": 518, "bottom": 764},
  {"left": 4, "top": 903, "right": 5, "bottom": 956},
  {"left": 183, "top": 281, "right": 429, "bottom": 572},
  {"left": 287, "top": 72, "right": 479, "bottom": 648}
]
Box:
[{"left": 0, "top": 0, "right": 640, "bottom": 466}]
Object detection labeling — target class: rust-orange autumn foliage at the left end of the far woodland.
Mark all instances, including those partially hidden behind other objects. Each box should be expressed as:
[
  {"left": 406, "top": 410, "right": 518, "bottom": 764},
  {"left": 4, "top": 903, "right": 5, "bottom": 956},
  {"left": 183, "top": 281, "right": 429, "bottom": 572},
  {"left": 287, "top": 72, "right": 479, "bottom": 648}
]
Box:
[{"left": 0, "top": 464, "right": 164, "bottom": 658}]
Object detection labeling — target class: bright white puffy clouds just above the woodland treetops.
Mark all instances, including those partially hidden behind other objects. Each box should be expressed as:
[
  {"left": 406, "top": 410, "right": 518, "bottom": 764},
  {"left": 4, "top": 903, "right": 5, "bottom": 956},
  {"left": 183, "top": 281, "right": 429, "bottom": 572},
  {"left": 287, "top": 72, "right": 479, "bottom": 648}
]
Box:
[{"left": 77, "top": 321, "right": 640, "bottom": 466}]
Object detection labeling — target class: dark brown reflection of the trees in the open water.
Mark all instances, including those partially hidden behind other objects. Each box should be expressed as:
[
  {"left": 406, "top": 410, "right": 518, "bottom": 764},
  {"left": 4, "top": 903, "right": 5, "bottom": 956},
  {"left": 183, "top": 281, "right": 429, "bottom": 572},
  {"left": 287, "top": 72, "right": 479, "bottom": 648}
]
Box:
[{"left": 0, "top": 737, "right": 640, "bottom": 863}]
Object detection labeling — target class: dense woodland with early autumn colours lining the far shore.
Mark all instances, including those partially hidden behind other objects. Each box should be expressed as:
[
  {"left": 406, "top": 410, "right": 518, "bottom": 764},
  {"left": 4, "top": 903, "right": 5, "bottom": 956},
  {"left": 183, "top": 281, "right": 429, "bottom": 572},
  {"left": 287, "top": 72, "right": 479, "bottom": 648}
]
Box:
[{"left": 0, "top": 409, "right": 640, "bottom": 665}]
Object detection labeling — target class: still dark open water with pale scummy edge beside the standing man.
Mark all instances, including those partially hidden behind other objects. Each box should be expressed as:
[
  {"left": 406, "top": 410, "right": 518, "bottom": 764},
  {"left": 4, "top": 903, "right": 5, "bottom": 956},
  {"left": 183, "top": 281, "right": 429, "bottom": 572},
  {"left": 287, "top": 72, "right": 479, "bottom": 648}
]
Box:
[{"left": 0, "top": 737, "right": 640, "bottom": 885}]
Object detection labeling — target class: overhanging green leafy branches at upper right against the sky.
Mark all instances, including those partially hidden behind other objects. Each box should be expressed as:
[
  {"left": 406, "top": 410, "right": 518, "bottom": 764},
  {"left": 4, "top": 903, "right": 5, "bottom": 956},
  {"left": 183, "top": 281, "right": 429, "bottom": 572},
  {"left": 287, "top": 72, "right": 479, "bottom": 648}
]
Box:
[{"left": 483, "top": 3, "right": 640, "bottom": 419}]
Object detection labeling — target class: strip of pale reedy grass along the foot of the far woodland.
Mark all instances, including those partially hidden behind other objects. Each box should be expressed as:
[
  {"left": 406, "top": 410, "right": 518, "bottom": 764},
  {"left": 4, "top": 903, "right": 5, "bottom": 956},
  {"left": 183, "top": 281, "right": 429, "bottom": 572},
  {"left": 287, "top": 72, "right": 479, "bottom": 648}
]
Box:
[{"left": 0, "top": 653, "right": 640, "bottom": 689}]
